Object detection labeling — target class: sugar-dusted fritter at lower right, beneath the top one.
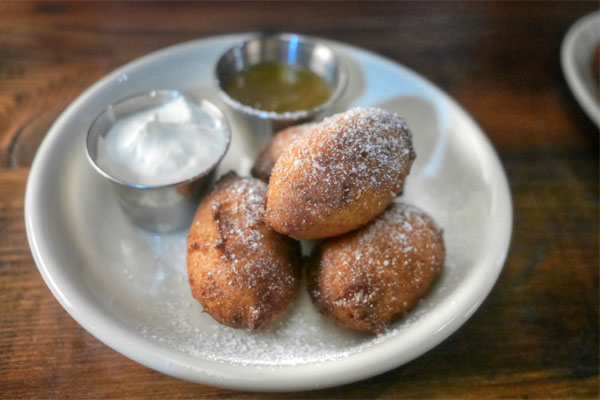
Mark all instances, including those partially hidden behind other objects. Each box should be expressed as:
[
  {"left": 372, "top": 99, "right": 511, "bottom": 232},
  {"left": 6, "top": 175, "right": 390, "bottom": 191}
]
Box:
[{"left": 307, "top": 203, "right": 445, "bottom": 333}]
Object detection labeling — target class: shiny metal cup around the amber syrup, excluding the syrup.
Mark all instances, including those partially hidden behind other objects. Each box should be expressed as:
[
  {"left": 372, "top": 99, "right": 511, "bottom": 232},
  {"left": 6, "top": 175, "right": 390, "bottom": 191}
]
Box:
[{"left": 215, "top": 33, "right": 348, "bottom": 133}]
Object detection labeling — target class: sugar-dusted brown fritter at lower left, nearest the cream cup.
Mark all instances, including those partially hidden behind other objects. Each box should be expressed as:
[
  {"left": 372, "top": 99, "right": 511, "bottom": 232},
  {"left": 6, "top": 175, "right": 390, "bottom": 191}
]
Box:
[{"left": 187, "top": 173, "right": 301, "bottom": 329}]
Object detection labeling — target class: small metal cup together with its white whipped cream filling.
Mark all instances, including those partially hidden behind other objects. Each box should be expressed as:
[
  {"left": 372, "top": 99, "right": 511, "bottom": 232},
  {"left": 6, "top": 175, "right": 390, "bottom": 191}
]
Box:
[{"left": 86, "top": 90, "right": 231, "bottom": 232}]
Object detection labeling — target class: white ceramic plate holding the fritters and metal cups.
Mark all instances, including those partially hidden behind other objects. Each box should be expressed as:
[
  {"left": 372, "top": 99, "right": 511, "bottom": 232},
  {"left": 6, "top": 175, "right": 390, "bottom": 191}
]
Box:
[{"left": 25, "top": 35, "right": 512, "bottom": 391}]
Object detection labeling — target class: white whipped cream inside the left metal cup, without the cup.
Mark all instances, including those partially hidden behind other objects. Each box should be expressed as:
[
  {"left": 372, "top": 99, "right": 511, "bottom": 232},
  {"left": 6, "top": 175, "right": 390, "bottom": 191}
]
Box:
[{"left": 97, "top": 97, "right": 228, "bottom": 186}]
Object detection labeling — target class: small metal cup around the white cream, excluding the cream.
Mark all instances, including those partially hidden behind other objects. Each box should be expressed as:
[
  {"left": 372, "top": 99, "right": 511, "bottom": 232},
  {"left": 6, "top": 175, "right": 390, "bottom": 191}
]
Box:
[{"left": 86, "top": 90, "right": 231, "bottom": 232}]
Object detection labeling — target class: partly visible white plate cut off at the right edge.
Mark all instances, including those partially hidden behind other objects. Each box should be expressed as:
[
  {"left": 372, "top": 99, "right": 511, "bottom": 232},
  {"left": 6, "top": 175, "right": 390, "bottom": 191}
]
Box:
[{"left": 560, "top": 11, "right": 600, "bottom": 127}]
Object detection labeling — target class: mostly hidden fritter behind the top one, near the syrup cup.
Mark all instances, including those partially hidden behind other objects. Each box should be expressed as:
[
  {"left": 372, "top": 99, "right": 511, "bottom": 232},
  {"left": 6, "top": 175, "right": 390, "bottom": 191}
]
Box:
[{"left": 250, "top": 123, "right": 316, "bottom": 183}]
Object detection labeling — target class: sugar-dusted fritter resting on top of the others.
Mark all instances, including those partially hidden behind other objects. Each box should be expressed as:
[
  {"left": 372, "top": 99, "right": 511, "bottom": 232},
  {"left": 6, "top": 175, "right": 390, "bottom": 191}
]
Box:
[{"left": 267, "top": 108, "right": 415, "bottom": 239}]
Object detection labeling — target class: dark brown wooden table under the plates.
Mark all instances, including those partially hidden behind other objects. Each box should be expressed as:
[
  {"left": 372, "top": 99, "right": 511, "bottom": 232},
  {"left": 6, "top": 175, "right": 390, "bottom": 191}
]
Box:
[{"left": 0, "top": 1, "right": 600, "bottom": 399}]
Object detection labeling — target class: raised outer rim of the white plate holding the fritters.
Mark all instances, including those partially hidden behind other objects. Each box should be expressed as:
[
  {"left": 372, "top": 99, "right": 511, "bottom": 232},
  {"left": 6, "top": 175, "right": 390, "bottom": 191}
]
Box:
[{"left": 25, "top": 34, "right": 513, "bottom": 391}]
